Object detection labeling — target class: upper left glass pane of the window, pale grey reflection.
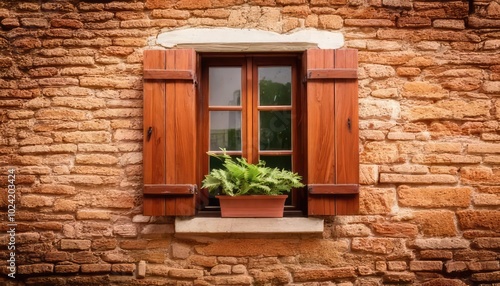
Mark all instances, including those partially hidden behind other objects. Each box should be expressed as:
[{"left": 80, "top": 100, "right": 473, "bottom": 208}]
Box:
[{"left": 208, "top": 67, "right": 241, "bottom": 106}]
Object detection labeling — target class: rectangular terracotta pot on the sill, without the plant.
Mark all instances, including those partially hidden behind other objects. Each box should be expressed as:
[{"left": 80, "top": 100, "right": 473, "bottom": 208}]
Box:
[{"left": 216, "top": 195, "right": 288, "bottom": 217}]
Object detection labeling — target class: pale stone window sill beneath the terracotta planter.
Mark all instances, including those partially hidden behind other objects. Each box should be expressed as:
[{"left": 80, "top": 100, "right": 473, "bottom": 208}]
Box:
[{"left": 175, "top": 217, "right": 324, "bottom": 234}]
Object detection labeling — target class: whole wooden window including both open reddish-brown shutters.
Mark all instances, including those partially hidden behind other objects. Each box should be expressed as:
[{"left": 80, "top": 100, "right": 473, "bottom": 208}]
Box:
[{"left": 143, "top": 49, "right": 359, "bottom": 216}]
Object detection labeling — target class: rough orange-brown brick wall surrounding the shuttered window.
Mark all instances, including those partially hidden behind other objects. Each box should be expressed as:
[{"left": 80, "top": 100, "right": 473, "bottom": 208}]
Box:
[{"left": 0, "top": 0, "right": 500, "bottom": 286}]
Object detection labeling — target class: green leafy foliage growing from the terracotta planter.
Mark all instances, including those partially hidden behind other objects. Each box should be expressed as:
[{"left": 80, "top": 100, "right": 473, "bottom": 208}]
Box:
[{"left": 202, "top": 149, "right": 304, "bottom": 196}]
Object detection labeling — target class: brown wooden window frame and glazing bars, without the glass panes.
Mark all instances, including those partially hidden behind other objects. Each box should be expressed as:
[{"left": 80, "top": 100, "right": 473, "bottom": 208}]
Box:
[{"left": 197, "top": 52, "right": 307, "bottom": 217}]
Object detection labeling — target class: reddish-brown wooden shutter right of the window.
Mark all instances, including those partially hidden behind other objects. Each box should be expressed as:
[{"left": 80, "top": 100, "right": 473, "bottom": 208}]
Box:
[{"left": 303, "top": 49, "right": 359, "bottom": 215}]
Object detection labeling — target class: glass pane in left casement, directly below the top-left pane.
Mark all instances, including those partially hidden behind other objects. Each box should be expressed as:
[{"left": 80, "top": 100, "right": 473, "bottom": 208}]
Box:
[{"left": 210, "top": 111, "right": 241, "bottom": 151}]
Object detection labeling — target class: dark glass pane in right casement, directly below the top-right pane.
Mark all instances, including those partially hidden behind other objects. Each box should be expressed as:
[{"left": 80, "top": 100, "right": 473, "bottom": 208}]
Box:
[{"left": 259, "top": 110, "right": 292, "bottom": 150}]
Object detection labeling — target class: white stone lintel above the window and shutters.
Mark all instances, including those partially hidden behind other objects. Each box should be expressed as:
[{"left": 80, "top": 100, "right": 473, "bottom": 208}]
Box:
[{"left": 155, "top": 28, "right": 344, "bottom": 52}]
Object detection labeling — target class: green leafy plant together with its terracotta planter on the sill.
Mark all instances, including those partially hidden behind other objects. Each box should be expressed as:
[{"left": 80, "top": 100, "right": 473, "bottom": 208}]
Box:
[{"left": 202, "top": 149, "right": 304, "bottom": 217}]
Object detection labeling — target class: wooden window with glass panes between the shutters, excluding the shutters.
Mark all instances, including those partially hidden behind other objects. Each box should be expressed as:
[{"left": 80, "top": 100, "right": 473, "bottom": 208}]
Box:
[{"left": 200, "top": 54, "right": 305, "bottom": 215}]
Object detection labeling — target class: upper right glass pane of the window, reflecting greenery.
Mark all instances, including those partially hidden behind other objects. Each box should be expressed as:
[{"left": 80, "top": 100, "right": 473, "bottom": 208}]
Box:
[{"left": 259, "top": 67, "right": 292, "bottom": 106}]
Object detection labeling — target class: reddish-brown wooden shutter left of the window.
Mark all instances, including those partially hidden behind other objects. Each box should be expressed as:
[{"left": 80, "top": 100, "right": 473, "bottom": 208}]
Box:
[{"left": 143, "top": 49, "right": 198, "bottom": 216}]
